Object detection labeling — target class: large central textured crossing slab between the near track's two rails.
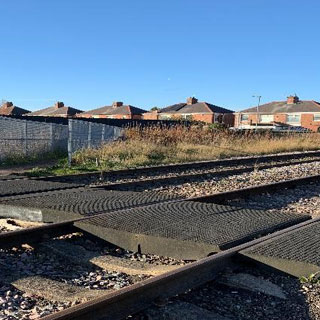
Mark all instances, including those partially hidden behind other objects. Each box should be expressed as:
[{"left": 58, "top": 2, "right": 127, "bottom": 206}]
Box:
[{"left": 75, "top": 201, "right": 310, "bottom": 260}]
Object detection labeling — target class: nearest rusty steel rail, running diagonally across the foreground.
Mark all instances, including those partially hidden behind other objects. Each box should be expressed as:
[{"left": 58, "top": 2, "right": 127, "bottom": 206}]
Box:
[{"left": 43, "top": 218, "right": 320, "bottom": 320}]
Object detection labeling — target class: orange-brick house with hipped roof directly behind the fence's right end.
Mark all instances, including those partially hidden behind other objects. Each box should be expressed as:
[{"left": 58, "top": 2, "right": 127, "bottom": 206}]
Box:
[{"left": 77, "top": 101, "right": 146, "bottom": 120}]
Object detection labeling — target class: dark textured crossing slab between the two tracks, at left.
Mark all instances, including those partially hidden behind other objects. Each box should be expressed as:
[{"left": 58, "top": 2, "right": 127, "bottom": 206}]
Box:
[{"left": 0, "top": 188, "right": 180, "bottom": 222}]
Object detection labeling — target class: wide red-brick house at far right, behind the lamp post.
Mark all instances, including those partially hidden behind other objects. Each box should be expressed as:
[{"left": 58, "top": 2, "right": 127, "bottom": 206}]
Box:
[{"left": 235, "top": 95, "right": 320, "bottom": 132}]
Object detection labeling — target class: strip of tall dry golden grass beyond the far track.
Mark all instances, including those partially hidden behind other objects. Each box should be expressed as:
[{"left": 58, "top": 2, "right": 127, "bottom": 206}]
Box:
[{"left": 74, "top": 125, "right": 320, "bottom": 170}]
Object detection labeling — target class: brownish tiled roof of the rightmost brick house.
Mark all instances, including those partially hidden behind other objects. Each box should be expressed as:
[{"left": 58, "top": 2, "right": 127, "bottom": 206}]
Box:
[{"left": 240, "top": 100, "right": 320, "bottom": 114}]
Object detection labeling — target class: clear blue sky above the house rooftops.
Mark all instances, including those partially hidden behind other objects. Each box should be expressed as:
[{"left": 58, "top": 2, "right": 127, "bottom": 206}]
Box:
[{"left": 0, "top": 0, "right": 320, "bottom": 110}]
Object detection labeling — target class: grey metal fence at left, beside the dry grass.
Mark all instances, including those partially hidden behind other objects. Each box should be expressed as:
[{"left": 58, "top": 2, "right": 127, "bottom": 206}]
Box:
[{"left": 0, "top": 117, "right": 122, "bottom": 162}]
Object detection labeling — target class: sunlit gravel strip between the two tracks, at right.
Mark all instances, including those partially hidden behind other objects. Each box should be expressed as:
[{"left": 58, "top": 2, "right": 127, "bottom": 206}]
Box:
[{"left": 151, "top": 161, "right": 320, "bottom": 198}]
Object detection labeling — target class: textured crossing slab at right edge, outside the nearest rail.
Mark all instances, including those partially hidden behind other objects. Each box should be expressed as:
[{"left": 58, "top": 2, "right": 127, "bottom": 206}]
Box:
[{"left": 240, "top": 221, "right": 320, "bottom": 277}]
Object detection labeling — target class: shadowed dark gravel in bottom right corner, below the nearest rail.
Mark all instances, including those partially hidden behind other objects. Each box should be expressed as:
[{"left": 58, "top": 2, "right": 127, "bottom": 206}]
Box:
[{"left": 132, "top": 266, "right": 320, "bottom": 320}]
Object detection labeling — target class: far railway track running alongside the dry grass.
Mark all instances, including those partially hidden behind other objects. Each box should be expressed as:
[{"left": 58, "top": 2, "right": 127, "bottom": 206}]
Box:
[{"left": 0, "top": 151, "right": 320, "bottom": 199}]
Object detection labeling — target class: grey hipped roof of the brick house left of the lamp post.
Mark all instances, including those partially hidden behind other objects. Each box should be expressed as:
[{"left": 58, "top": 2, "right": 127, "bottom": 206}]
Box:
[{"left": 159, "top": 102, "right": 233, "bottom": 114}]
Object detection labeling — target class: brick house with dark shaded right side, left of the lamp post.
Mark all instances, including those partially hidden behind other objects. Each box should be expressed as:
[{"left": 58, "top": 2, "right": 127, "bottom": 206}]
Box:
[{"left": 143, "top": 97, "right": 234, "bottom": 126}]
